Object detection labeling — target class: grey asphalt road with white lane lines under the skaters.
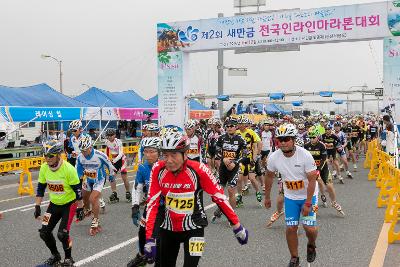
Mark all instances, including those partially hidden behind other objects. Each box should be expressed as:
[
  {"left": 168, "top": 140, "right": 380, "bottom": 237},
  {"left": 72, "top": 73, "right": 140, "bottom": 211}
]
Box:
[{"left": 0, "top": 160, "right": 400, "bottom": 267}]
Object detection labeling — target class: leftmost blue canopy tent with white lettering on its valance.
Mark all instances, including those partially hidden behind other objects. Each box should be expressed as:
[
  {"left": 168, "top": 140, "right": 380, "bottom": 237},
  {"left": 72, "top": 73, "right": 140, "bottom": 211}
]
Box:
[{"left": 0, "top": 83, "right": 91, "bottom": 122}]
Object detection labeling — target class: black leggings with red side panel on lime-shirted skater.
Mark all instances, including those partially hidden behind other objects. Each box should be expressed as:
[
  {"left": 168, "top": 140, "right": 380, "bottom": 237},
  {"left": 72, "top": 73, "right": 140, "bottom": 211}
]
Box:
[{"left": 39, "top": 200, "right": 76, "bottom": 258}]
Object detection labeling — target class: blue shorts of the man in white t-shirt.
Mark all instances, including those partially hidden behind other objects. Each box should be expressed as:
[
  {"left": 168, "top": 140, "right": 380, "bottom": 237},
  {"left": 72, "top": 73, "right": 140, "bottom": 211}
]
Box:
[{"left": 285, "top": 196, "right": 318, "bottom": 226}]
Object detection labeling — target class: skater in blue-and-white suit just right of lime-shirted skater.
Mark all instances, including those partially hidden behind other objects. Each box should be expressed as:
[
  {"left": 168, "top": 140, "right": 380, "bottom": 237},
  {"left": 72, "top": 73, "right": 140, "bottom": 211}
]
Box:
[{"left": 76, "top": 136, "right": 115, "bottom": 235}]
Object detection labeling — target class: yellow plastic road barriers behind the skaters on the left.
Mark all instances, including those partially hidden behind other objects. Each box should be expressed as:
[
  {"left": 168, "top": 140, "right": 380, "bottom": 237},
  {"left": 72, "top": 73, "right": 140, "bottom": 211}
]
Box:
[{"left": 0, "top": 146, "right": 139, "bottom": 196}]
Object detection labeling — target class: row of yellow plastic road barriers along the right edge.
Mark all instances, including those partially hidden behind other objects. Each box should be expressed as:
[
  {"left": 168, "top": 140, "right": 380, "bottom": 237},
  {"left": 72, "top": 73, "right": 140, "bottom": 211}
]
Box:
[{"left": 364, "top": 140, "right": 400, "bottom": 243}]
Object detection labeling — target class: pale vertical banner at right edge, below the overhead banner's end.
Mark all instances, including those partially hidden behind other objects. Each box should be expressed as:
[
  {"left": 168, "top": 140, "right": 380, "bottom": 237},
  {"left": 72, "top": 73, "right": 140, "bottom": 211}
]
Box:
[{"left": 383, "top": 37, "right": 400, "bottom": 123}]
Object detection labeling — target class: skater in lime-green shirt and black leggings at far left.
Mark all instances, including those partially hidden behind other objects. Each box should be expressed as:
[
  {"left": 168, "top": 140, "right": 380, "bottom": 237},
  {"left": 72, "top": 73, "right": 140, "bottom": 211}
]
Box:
[{"left": 34, "top": 140, "right": 83, "bottom": 266}]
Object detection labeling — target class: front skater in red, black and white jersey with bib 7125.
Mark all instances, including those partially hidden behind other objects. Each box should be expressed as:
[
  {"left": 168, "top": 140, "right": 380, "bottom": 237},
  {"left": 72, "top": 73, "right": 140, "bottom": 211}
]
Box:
[{"left": 144, "top": 131, "right": 248, "bottom": 267}]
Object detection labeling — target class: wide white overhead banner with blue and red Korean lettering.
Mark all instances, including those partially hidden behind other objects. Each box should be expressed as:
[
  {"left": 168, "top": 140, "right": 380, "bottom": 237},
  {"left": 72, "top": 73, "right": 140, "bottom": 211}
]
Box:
[{"left": 157, "top": 1, "right": 400, "bottom": 53}]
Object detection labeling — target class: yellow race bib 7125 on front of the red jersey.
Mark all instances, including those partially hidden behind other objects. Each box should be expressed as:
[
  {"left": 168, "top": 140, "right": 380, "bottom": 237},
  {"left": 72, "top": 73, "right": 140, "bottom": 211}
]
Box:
[{"left": 165, "top": 192, "right": 194, "bottom": 214}]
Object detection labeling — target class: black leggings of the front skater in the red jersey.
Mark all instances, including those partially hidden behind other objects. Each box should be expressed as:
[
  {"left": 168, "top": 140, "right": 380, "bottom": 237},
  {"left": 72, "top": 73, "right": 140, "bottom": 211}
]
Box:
[{"left": 160, "top": 228, "right": 204, "bottom": 267}]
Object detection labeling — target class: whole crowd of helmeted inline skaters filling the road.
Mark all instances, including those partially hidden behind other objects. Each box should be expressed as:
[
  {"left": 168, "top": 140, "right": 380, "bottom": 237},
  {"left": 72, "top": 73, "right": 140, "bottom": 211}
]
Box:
[{"left": 22, "top": 112, "right": 393, "bottom": 267}]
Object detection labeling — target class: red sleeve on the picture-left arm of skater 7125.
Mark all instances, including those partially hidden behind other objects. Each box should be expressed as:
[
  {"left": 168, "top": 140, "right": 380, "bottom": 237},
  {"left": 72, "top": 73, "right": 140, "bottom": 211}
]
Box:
[{"left": 146, "top": 163, "right": 161, "bottom": 239}]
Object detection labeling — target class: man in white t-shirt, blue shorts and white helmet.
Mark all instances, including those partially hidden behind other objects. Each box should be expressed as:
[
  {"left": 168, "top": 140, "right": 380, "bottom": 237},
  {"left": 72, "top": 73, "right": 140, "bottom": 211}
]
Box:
[{"left": 264, "top": 124, "right": 318, "bottom": 267}]
